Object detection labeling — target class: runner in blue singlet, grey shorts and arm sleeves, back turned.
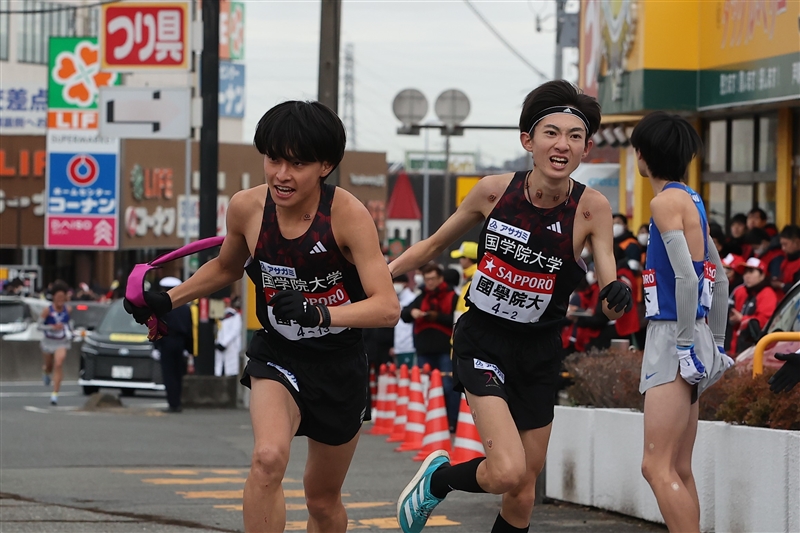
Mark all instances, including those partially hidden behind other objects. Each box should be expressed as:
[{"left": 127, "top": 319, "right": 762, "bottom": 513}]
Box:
[{"left": 631, "top": 112, "right": 733, "bottom": 533}]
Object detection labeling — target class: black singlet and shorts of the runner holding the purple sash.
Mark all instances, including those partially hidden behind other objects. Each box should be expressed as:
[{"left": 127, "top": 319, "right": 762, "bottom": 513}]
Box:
[{"left": 242, "top": 184, "right": 369, "bottom": 445}]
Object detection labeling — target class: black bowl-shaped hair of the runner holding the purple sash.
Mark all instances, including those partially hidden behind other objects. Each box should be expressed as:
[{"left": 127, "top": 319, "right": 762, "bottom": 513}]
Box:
[{"left": 253, "top": 100, "right": 347, "bottom": 177}]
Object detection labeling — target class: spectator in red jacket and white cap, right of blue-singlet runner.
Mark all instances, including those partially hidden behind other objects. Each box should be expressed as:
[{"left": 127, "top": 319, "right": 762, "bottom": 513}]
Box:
[{"left": 728, "top": 257, "right": 778, "bottom": 353}]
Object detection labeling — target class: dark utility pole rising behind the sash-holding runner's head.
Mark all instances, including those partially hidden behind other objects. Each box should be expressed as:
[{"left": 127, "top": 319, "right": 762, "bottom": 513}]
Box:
[{"left": 316, "top": 0, "right": 342, "bottom": 185}]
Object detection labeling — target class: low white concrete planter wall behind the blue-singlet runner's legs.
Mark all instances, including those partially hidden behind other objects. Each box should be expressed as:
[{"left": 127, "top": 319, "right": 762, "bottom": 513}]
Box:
[{"left": 545, "top": 406, "right": 800, "bottom": 533}]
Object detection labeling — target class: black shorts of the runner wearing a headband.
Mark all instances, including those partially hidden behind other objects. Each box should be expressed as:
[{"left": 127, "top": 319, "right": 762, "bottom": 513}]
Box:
[{"left": 453, "top": 310, "right": 562, "bottom": 431}]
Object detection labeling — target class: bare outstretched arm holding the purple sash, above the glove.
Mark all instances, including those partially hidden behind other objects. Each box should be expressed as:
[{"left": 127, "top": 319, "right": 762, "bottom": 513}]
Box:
[{"left": 167, "top": 188, "right": 255, "bottom": 309}]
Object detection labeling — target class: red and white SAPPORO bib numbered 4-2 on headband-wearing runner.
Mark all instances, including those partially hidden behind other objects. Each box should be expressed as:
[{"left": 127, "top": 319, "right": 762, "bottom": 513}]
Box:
[{"left": 469, "top": 252, "right": 556, "bottom": 323}]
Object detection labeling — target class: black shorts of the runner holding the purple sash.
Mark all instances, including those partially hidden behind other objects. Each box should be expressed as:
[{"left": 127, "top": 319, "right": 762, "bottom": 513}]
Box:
[{"left": 241, "top": 332, "right": 370, "bottom": 446}]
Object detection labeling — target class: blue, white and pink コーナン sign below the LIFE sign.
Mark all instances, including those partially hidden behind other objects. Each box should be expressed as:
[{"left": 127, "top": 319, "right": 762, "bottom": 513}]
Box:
[{"left": 45, "top": 131, "right": 119, "bottom": 250}]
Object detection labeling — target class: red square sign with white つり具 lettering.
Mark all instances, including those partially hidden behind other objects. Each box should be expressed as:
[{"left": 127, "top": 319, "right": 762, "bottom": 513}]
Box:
[{"left": 100, "top": 2, "right": 191, "bottom": 71}]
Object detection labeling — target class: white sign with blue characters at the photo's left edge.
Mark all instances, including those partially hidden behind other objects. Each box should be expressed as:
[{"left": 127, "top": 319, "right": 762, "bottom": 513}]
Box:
[{"left": 0, "top": 84, "right": 47, "bottom": 135}]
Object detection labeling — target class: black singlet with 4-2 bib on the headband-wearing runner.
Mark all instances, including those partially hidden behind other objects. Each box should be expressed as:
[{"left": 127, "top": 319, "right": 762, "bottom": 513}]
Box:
[{"left": 469, "top": 172, "right": 586, "bottom": 330}]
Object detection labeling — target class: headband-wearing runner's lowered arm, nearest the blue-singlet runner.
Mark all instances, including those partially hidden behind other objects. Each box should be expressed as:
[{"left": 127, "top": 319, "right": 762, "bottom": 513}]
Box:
[{"left": 575, "top": 187, "right": 625, "bottom": 320}]
